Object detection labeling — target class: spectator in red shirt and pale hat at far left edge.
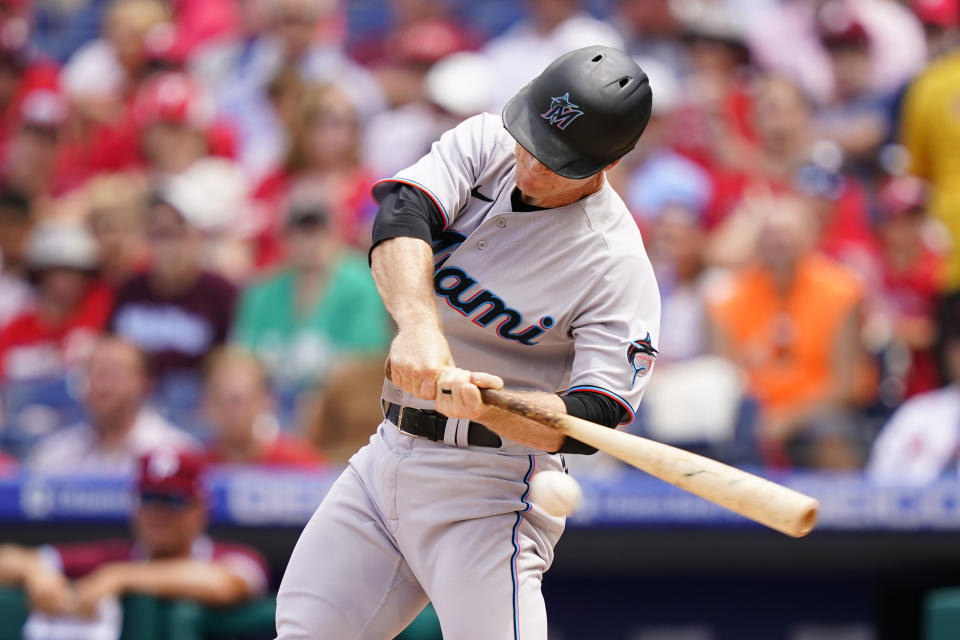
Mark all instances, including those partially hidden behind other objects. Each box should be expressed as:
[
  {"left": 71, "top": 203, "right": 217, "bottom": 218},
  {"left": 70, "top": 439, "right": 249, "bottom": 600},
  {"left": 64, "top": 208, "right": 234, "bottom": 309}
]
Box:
[{"left": 0, "top": 220, "right": 111, "bottom": 382}]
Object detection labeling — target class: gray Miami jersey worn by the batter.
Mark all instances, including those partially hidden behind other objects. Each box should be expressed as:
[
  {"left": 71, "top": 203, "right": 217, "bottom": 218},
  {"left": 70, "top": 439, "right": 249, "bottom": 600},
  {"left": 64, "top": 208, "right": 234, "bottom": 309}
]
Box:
[{"left": 374, "top": 114, "right": 660, "bottom": 436}]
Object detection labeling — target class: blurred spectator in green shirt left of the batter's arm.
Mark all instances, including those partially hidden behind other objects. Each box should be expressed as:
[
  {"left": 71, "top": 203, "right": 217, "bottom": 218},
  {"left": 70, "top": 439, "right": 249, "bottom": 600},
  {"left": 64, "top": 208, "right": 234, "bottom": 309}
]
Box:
[{"left": 234, "top": 202, "right": 392, "bottom": 392}]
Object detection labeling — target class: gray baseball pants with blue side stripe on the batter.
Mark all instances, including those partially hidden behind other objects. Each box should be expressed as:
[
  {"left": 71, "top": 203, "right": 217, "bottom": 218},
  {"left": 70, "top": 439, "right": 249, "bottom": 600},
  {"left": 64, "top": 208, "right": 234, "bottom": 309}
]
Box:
[{"left": 277, "top": 421, "right": 564, "bottom": 640}]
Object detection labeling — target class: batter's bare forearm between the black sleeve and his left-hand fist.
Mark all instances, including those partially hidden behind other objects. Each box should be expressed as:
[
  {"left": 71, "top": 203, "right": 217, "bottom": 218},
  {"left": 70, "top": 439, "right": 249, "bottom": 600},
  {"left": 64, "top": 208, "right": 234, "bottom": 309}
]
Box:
[{"left": 370, "top": 237, "right": 440, "bottom": 331}]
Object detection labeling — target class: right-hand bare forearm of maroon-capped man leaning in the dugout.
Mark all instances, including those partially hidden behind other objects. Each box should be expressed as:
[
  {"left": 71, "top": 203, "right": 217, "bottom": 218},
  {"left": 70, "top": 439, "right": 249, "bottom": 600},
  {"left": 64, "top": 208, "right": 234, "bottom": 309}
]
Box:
[{"left": 105, "top": 560, "right": 252, "bottom": 606}]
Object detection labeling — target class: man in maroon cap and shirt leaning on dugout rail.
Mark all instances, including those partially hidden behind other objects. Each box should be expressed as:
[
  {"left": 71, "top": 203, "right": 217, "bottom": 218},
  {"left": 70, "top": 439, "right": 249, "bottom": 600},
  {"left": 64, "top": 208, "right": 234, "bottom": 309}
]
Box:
[{"left": 0, "top": 449, "right": 267, "bottom": 617}]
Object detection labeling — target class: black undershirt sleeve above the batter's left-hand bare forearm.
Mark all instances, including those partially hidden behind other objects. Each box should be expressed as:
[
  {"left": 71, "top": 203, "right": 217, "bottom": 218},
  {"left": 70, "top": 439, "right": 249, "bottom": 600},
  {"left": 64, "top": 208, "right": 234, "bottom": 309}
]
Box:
[{"left": 370, "top": 182, "right": 444, "bottom": 258}]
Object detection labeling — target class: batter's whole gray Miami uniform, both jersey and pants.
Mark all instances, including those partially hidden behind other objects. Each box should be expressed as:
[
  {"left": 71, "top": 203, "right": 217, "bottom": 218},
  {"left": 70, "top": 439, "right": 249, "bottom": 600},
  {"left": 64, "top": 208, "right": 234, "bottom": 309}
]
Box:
[{"left": 277, "top": 115, "right": 660, "bottom": 640}]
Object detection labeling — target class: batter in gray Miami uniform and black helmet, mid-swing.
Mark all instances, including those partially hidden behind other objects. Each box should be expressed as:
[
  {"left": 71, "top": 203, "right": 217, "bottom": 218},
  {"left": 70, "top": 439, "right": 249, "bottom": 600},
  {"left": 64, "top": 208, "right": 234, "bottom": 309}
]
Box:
[{"left": 277, "top": 46, "right": 660, "bottom": 640}]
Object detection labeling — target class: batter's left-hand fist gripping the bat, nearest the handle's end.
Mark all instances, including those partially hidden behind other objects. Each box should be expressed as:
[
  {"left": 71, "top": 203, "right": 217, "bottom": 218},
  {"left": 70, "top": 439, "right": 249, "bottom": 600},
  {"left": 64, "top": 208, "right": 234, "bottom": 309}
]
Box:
[{"left": 389, "top": 327, "right": 453, "bottom": 400}]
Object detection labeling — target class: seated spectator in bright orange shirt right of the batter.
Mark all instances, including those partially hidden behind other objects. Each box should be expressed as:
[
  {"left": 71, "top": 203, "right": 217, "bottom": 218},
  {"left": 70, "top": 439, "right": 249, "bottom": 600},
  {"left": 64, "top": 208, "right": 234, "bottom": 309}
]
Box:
[{"left": 710, "top": 192, "right": 863, "bottom": 468}]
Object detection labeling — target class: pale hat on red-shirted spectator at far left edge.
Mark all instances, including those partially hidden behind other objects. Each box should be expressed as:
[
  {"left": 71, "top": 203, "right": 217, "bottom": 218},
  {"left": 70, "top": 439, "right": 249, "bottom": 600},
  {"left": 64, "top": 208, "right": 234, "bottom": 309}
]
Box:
[{"left": 24, "top": 220, "right": 99, "bottom": 271}]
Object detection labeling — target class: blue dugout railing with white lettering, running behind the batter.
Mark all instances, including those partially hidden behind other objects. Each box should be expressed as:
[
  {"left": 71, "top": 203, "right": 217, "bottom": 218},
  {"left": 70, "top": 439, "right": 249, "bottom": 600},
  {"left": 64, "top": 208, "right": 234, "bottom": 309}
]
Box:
[{"left": 0, "top": 469, "right": 960, "bottom": 531}]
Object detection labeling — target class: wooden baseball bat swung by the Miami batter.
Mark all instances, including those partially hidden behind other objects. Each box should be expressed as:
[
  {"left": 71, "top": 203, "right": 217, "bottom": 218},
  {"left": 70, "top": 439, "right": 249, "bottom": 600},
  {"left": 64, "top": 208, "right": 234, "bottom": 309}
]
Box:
[{"left": 480, "top": 389, "right": 820, "bottom": 538}]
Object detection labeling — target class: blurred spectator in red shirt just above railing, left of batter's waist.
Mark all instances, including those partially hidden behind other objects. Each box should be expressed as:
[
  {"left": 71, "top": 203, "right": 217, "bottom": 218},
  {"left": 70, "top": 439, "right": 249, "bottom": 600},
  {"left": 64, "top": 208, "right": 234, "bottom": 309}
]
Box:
[{"left": 203, "top": 347, "right": 320, "bottom": 467}]
